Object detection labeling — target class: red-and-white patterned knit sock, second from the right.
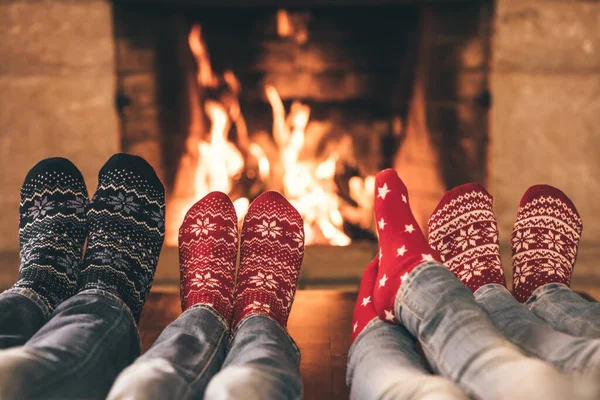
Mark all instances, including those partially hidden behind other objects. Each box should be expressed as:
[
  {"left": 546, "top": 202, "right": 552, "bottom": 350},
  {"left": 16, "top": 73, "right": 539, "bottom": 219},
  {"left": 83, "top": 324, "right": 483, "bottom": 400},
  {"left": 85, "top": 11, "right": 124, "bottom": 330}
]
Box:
[{"left": 429, "top": 183, "right": 506, "bottom": 292}]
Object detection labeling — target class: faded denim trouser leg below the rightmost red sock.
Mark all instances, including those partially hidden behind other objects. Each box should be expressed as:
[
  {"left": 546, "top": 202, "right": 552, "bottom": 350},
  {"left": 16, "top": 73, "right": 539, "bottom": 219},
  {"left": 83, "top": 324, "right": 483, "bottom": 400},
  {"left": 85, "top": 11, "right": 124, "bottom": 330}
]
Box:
[{"left": 525, "top": 283, "right": 600, "bottom": 338}]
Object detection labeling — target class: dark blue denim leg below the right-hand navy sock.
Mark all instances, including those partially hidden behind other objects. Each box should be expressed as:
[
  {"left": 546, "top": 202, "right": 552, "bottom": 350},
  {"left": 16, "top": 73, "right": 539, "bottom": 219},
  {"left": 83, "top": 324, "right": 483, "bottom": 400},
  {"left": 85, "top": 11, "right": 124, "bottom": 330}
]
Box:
[{"left": 0, "top": 290, "right": 140, "bottom": 399}]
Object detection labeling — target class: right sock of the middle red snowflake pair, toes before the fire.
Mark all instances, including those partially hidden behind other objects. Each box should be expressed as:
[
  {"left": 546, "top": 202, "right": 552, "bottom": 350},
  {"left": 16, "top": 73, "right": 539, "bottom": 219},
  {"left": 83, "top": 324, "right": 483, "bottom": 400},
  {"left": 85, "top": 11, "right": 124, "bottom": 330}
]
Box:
[{"left": 233, "top": 192, "right": 304, "bottom": 329}]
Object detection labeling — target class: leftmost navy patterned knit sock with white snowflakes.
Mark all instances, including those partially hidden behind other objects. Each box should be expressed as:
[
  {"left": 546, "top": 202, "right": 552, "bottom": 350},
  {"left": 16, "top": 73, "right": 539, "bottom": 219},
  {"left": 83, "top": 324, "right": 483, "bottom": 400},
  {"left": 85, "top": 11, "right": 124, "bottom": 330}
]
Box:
[{"left": 9, "top": 158, "right": 88, "bottom": 314}]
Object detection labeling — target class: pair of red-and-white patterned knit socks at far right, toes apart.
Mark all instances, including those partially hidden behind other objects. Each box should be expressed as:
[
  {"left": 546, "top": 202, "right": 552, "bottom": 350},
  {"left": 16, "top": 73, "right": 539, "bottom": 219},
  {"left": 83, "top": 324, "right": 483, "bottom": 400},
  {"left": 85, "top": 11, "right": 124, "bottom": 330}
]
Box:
[{"left": 429, "top": 183, "right": 583, "bottom": 303}]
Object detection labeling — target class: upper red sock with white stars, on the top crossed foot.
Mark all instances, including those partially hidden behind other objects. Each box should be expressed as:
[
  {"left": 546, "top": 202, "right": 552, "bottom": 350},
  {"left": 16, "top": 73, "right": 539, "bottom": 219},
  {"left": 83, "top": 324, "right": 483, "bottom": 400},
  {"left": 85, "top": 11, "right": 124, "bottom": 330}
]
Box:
[{"left": 373, "top": 169, "right": 440, "bottom": 322}]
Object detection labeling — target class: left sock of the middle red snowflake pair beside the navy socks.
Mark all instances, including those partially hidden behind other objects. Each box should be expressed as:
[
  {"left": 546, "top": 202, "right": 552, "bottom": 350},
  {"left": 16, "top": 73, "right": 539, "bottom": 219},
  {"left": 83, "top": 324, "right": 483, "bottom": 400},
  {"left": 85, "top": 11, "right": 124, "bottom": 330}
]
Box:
[{"left": 179, "top": 192, "right": 238, "bottom": 323}]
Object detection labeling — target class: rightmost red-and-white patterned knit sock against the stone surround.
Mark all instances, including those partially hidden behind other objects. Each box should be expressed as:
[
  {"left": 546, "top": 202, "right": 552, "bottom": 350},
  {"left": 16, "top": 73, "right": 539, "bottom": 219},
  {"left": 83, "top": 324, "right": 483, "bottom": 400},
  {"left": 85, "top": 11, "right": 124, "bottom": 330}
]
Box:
[{"left": 512, "top": 185, "right": 583, "bottom": 303}]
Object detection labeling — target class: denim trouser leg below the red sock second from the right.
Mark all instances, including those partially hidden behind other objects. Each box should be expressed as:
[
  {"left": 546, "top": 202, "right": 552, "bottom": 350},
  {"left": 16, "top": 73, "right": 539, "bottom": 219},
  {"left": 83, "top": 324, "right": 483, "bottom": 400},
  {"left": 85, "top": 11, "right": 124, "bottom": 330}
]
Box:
[{"left": 475, "top": 284, "right": 600, "bottom": 374}]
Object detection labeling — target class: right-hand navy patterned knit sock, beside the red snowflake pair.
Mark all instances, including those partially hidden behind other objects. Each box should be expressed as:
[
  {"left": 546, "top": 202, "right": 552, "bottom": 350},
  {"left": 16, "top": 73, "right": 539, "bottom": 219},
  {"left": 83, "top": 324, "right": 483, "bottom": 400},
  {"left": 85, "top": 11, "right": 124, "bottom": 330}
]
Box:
[{"left": 79, "top": 154, "right": 165, "bottom": 321}]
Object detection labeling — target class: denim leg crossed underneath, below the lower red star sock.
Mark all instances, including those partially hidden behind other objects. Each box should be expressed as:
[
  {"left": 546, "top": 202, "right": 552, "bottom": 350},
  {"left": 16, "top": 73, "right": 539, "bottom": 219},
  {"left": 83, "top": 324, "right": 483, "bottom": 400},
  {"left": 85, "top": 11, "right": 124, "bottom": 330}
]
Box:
[{"left": 346, "top": 318, "right": 468, "bottom": 400}]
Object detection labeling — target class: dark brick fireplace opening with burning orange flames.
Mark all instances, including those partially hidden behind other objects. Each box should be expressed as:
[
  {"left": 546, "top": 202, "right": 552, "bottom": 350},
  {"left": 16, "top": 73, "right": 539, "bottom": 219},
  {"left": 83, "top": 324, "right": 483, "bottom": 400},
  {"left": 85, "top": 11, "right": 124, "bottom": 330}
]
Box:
[{"left": 114, "top": 1, "right": 493, "bottom": 256}]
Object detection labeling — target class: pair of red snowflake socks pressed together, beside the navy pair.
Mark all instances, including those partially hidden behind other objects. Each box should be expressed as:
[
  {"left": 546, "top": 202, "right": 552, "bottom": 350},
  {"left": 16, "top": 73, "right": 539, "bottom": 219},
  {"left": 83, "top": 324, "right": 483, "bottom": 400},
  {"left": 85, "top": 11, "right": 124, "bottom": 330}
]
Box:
[{"left": 179, "top": 192, "right": 304, "bottom": 329}]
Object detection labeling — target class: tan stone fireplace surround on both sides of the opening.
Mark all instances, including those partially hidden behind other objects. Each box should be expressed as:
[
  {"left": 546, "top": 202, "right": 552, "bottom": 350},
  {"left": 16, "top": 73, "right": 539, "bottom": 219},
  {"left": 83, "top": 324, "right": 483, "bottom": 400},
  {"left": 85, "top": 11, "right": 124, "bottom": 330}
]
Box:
[{"left": 0, "top": 0, "right": 600, "bottom": 287}]
